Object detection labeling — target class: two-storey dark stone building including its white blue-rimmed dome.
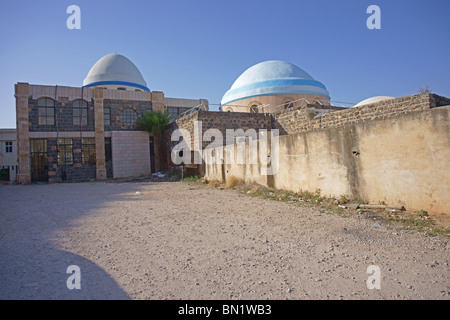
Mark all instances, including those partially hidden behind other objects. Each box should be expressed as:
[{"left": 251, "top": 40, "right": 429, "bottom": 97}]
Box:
[{"left": 15, "top": 53, "right": 208, "bottom": 183}]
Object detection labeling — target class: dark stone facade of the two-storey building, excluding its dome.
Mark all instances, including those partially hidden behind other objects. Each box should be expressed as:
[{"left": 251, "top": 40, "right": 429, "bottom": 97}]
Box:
[{"left": 15, "top": 83, "right": 208, "bottom": 183}]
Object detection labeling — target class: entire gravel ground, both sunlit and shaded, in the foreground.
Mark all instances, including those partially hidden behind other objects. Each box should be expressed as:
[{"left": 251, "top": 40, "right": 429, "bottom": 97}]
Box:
[{"left": 0, "top": 182, "right": 450, "bottom": 300}]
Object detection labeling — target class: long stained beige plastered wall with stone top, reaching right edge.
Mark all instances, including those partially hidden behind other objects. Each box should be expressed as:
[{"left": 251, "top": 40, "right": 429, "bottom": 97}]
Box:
[{"left": 203, "top": 94, "right": 450, "bottom": 214}]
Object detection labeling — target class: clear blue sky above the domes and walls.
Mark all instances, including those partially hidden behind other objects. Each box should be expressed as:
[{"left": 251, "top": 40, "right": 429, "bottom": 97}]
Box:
[{"left": 0, "top": 0, "right": 450, "bottom": 128}]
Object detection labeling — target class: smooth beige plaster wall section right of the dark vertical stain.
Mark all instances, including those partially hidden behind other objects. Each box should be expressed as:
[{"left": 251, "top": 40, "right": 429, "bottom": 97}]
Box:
[{"left": 356, "top": 106, "right": 450, "bottom": 214}]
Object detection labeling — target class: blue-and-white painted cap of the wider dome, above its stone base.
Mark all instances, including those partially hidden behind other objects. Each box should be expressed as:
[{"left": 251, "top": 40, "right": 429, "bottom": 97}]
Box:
[{"left": 221, "top": 60, "right": 330, "bottom": 105}]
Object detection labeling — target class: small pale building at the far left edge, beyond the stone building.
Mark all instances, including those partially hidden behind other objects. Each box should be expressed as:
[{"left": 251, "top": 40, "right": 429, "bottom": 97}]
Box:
[{"left": 0, "top": 129, "right": 17, "bottom": 181}]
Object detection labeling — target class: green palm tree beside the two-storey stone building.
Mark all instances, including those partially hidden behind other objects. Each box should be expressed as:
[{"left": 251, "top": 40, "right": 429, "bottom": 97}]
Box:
[{"left": 136, "top": 108, "right": 171, "bottom": 171}]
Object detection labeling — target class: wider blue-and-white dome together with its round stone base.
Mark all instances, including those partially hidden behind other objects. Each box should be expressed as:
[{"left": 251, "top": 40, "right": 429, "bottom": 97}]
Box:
[{"left": 221, "top": 60, "right": 330, "bottom": 113}]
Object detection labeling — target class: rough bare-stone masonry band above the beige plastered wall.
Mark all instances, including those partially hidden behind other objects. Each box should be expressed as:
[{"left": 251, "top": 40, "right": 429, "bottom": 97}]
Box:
[{"left": 172, "top": 93, "right": 450, "bottom": 147}]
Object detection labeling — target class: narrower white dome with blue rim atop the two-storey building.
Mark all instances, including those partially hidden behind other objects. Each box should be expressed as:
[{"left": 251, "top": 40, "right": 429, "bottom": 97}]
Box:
[{"left": 83, "top": 53, "right": 150, "bottom": 91}]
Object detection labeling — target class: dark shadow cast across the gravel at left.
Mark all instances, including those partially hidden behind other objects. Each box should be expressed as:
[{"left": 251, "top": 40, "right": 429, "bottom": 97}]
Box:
[{"left": 0, "top": 182, "right": 151, "bottom": 300}]
